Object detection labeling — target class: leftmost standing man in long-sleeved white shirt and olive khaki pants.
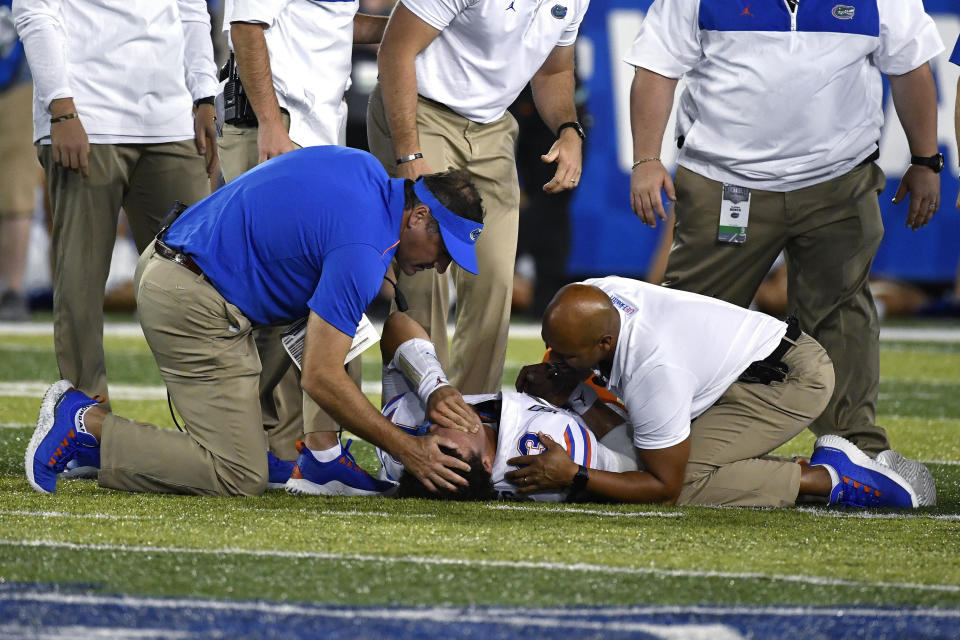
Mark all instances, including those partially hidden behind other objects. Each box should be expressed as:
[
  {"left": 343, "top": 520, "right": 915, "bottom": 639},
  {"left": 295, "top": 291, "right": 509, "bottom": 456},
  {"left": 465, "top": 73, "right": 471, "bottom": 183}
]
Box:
[{"left": 13, "top": 0, "right": 217, "bottom": 410}]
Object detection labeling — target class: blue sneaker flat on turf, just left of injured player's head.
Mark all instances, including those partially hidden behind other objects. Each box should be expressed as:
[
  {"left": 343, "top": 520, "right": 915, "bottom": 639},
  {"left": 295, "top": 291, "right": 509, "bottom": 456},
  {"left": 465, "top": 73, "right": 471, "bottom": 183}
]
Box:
[{"left": 286, "top": 440, "right": 396, "bottom": 496}]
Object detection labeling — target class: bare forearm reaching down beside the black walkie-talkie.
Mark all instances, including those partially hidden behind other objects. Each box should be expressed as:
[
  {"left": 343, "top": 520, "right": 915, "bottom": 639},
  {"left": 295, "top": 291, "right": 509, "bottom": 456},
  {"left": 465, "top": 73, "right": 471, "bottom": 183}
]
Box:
[{"left": 230, "top": 22, "right": 297, "bottom": 162}]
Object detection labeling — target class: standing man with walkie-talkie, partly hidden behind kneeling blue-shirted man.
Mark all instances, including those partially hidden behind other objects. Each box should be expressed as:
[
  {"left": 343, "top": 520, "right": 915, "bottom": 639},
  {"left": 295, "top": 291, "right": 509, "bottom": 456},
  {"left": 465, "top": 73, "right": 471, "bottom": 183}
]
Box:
[{"left": 220, "top": 0, "right": 387, "bottom": 470}]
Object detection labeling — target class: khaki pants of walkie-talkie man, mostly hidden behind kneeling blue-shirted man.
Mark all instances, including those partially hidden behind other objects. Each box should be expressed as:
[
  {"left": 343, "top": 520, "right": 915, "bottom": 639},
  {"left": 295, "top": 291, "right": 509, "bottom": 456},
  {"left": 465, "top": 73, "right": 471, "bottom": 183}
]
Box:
[{"left": 219, "top": 119, "right": 362, "bottom": 460}]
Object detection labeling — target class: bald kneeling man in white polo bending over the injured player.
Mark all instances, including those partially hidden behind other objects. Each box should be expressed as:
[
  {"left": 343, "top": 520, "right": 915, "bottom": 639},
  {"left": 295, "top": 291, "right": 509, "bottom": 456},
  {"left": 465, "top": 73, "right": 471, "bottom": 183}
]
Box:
[{"left": 506, "top": 277, "right": 936, "bottom": 508}]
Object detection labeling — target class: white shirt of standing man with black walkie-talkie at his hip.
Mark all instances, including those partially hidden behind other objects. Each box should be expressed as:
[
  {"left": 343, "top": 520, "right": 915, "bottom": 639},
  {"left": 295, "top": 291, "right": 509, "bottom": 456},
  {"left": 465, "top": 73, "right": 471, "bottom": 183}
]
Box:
[{"left": 223, "top": 0, "right": 360, "bottom": 147}]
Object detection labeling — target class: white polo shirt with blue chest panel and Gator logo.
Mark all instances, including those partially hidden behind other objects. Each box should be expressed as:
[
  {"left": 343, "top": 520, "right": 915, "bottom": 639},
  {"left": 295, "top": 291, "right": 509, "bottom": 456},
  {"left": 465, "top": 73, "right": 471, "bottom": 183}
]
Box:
[{"left": 624, "top": 0, "right": 943, "bottom": 191}]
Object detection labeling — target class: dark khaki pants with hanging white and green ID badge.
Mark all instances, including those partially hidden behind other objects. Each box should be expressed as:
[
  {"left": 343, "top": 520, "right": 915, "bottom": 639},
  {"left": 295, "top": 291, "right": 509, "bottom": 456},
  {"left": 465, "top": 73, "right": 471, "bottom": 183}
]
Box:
[{"left": 664, "top": 163, "right": 890, "bottom": 455}]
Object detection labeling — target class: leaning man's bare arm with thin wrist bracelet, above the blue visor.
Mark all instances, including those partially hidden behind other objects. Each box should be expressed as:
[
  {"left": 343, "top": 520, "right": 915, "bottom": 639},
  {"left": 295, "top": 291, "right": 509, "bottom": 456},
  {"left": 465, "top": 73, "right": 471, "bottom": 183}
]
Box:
[{"left": 377, "top": 2, "right": 440, "bottom": 180}]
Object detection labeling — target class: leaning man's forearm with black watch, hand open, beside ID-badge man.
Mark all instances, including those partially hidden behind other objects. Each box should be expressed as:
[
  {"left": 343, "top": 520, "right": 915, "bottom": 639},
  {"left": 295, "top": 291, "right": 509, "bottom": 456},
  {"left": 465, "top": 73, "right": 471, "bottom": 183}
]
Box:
[{"left": 530, "top": 45, "right": 583, "bottom": 193}]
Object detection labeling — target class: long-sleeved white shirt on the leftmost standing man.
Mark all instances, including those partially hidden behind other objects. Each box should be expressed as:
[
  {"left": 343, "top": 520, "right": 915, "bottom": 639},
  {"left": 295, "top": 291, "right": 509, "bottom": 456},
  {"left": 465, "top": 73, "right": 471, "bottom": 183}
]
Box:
[{"left": 13, "top": 0, "right": 217, "bottom": 144}]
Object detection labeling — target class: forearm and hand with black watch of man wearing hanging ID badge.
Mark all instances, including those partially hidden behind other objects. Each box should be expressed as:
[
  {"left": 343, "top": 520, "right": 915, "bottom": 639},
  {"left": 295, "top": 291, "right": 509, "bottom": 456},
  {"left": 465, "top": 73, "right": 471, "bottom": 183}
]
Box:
[{"left": 887, "top": 62, "right": 940, "bottom": 230}]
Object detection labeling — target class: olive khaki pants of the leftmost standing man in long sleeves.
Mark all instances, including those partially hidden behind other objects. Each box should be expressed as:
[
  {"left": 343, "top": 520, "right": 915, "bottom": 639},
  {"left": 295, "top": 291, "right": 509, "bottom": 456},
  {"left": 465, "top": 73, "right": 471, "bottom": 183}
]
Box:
[{"left": 37, "top": 140, "right": 210, "bottom": 406}]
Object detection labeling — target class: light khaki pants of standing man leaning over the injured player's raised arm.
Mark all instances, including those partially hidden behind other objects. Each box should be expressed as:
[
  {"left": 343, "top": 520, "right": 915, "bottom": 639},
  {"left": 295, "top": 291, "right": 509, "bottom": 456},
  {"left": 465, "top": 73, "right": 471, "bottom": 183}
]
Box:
[{"left": 367, "top": 85, "right": 520, "bottom": 393}]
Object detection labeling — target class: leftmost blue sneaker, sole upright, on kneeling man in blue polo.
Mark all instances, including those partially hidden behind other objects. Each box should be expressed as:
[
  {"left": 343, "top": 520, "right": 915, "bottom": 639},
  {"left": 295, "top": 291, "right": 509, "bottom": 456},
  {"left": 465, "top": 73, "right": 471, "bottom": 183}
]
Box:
[{"left": 24, "top": 380, "right": 100, "bottom": 493}]
